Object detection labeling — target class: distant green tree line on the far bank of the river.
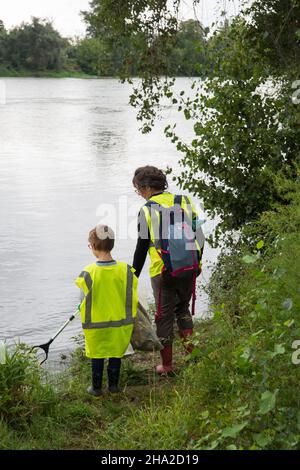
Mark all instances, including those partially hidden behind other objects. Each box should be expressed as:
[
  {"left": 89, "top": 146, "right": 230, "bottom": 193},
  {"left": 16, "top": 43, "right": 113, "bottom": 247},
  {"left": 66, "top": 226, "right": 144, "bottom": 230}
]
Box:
[{"left": 0, "top": 17, "right": 206, "bottom": 76}]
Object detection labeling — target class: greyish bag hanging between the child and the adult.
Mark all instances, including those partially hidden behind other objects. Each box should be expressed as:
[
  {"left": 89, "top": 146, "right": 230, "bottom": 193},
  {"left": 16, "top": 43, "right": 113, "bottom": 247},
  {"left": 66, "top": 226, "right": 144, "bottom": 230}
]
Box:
[{"left": 131, "top": 303, "right": 163, "bottom": 351}]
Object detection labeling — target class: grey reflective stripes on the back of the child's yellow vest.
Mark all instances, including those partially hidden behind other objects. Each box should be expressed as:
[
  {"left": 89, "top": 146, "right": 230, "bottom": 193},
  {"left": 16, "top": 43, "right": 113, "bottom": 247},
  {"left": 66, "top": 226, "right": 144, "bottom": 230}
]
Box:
[{"left": 79, "top": 266, "right": 134, "bottom": 330}]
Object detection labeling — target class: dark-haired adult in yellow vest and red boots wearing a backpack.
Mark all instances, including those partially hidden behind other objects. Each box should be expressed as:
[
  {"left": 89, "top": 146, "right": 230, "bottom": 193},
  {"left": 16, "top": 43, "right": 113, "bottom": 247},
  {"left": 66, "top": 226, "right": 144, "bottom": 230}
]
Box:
[{"left": 133, "top": 166, "right": 203, "bottom": 374}]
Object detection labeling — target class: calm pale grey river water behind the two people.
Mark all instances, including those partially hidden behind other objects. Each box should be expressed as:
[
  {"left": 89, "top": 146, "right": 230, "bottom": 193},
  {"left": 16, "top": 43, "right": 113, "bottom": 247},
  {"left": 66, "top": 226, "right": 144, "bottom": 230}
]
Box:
[{"left": 0, "top": 78, "right": 216, "bottom": 362}]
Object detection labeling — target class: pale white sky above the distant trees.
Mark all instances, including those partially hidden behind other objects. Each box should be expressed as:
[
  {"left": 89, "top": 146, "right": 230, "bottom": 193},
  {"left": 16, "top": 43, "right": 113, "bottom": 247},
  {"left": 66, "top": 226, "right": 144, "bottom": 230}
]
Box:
[{"left": 0, "top": 0, "right": 240, "bottom": 37}]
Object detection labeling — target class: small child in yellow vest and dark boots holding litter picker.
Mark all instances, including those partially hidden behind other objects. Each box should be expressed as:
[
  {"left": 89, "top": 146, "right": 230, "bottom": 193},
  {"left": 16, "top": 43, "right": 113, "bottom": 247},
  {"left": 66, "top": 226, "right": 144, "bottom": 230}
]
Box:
[{"left": 76, "top": 225, "right": 138, "bottom": 397}]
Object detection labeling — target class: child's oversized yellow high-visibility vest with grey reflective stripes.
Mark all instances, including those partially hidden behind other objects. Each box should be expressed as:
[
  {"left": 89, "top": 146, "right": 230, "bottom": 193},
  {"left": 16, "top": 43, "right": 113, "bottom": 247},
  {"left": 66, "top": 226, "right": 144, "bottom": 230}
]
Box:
[{"left": 76, "top": 261, "right": 138, "bottom": 359}]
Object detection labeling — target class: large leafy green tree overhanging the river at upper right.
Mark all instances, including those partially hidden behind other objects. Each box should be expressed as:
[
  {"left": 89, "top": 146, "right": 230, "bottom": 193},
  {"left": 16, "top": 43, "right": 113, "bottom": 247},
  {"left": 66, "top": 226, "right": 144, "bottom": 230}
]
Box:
[{"left": 86, "top": 0, "right": 300, "bottom": 241}]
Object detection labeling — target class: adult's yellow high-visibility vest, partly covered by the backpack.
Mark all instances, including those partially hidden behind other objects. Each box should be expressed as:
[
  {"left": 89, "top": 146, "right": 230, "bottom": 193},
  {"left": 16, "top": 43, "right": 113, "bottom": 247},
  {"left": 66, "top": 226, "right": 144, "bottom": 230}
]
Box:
[{"left": 142, "top": 193, "right": 201, "bottom": 277}]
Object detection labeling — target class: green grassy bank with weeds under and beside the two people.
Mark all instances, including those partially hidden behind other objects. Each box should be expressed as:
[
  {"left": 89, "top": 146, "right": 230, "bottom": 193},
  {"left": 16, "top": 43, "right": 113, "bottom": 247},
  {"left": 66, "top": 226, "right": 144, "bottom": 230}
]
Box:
[{"left": 0, "top": 179, "right": 300, "bottom": 449}]
